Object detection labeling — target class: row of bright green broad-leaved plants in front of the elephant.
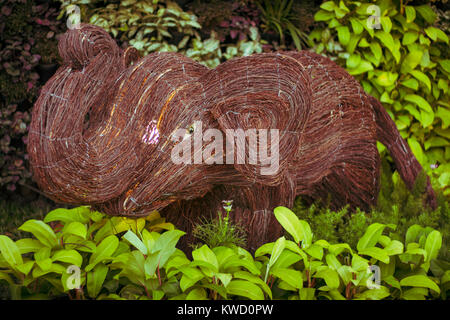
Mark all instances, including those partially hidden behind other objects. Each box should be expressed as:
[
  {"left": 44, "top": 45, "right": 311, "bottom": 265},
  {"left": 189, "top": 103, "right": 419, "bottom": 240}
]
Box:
[{"left": 0, "top": 207, "right": 450, "bottom": 300}]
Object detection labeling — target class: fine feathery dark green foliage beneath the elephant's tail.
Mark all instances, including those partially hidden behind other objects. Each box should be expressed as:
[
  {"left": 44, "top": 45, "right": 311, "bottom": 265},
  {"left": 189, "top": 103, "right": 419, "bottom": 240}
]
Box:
[{"left": 293, "top": 160, "right": 450, "bottom": 260}]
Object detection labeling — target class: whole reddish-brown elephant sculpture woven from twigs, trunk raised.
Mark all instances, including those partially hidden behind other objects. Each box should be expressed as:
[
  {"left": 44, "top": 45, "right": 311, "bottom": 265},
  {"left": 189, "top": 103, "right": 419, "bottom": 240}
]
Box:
[{"left": 28, "top": 24, "right": 436, "bottom": 250}]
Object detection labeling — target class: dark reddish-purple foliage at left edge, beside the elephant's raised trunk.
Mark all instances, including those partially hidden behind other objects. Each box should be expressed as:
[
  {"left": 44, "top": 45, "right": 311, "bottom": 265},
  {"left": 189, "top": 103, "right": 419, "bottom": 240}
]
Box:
[{"left": 0, "top": 0, "right": 63, "bottom": 191}]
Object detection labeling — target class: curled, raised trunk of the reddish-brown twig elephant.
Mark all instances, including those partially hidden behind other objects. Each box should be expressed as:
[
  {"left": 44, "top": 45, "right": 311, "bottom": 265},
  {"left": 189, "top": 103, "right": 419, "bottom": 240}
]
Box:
[{"left": 28, "top": 24, "right": 130, "bottom": 204}]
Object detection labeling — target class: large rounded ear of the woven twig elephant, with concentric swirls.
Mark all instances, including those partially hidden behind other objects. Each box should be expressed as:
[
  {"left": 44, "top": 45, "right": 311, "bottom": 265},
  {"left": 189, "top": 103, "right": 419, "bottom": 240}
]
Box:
[{"left": 204, "top": 54, "right": 311, "bottom": 186}]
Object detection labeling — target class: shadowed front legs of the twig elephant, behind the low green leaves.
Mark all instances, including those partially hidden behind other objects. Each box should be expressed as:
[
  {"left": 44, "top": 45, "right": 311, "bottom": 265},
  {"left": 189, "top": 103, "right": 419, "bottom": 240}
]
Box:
[{"left": 161, "top": 179, "right": 295, "bottom": 254}]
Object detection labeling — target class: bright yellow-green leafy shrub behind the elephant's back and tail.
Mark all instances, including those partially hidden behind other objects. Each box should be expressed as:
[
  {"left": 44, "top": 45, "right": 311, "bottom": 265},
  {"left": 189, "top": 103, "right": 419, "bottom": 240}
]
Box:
[{"left": 310, "top": 0, "right": 450, "bottom": 196}]
